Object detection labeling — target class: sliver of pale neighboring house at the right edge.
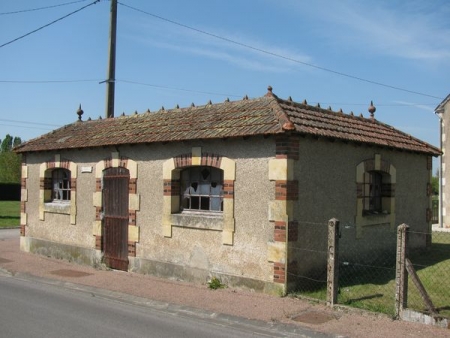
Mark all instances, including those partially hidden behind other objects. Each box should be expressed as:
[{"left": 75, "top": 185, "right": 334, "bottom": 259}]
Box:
[{"left": 434, "top": 95, "right": 450, "bottom": 228}]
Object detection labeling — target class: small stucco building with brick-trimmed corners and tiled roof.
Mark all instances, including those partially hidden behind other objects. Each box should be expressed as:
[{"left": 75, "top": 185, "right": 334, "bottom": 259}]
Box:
[{"left": 16, "top": 87, "right": 440, "bottom": 294}]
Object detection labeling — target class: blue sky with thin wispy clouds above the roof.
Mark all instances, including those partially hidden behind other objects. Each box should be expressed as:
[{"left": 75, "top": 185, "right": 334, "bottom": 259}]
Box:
[{"left": 0, "top": 0, "right": 450, "bottom": 168}]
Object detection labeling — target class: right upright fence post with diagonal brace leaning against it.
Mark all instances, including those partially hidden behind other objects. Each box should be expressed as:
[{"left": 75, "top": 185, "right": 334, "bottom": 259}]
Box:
[{"left": 395, "top": 223, "right": 409, "bottom": 318}]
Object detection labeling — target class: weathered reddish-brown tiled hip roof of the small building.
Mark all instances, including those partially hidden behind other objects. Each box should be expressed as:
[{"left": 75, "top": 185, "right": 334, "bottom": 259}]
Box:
[{"left": 16, "top": 88, "right": 440, "bottom": 156}]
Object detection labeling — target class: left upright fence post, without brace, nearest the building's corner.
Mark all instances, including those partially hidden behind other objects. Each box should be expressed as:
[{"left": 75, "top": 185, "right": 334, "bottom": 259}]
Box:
[{"left": 327, "top": 218, "right": 339, "bottom": 306}]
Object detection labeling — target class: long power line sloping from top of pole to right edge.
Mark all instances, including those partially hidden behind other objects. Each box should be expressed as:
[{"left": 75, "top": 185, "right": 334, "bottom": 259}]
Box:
[{"left": 118, "top": 2, "right": 443, "bottom": 100}]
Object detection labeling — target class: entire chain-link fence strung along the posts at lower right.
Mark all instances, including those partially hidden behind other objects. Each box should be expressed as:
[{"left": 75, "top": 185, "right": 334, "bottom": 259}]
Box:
[{"left": 288, "top": 222, "right": 450, "bottom": 318}]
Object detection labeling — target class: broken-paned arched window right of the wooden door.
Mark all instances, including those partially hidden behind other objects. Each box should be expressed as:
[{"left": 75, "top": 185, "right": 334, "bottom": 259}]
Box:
[{"left": 181, "top": 166, "right": 223, "bottom": 212}]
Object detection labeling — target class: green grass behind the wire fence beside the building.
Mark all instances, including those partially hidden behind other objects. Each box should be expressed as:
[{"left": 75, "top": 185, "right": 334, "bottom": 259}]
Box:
[{"left": 294, "top": 233, "right": 450, "bottom": 318}]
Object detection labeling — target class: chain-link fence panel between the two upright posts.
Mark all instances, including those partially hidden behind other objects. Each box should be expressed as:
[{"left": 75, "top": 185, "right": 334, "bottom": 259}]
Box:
[{"left": 337, "top": 223, "right": 396, "bottom": 315}]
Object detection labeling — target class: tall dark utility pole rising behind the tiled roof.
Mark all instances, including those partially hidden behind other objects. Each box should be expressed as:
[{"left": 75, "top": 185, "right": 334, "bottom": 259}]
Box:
[{"left": 105, "top": 0, "right": 117, "bottom": 118}]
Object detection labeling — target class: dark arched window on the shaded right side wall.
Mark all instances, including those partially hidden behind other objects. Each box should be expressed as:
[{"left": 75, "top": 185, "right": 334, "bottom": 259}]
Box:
[{"left": 362, "top": 171, "right": 383, "bottom": 214}]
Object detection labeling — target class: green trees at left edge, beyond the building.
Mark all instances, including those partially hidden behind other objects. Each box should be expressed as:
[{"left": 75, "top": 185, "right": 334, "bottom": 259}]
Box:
[{"left": 0, "top": 134, "right": 22, "bottom": 183}]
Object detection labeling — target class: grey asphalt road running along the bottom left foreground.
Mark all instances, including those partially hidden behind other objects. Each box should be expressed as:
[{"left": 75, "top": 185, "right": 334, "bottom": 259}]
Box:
[{"left": 0, "top": 272, "right": 326, "bottom": 338}]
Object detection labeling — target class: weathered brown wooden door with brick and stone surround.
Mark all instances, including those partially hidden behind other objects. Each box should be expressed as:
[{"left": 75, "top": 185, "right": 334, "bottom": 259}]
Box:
[{"left": 102, "top": 167, "right": 130, "bottom": 271}]
